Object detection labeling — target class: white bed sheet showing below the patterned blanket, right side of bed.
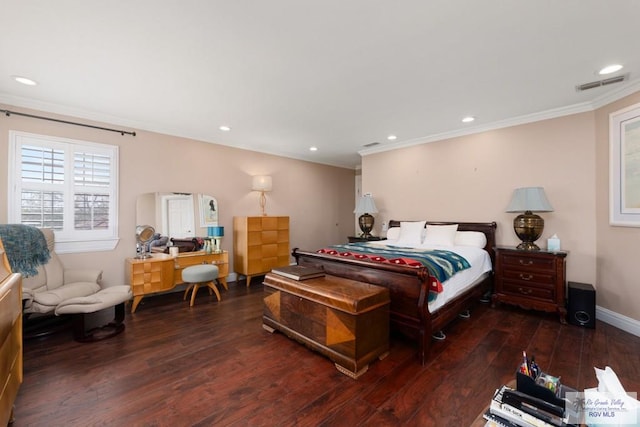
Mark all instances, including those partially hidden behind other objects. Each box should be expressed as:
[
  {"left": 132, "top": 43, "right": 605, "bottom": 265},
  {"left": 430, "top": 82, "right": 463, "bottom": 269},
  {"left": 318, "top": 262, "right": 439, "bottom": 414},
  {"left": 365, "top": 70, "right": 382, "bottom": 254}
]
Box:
[{"left": 367, "top": 240, "right": 492, "bottom": 313}]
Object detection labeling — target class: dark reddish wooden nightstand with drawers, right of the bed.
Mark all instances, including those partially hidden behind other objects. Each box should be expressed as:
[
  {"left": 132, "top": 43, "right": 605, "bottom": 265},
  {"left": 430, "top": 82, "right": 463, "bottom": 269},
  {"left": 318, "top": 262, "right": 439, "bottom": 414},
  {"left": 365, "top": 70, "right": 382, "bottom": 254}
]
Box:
[{"left": 492, "top": 246, "right": 567, "bottom": 323}]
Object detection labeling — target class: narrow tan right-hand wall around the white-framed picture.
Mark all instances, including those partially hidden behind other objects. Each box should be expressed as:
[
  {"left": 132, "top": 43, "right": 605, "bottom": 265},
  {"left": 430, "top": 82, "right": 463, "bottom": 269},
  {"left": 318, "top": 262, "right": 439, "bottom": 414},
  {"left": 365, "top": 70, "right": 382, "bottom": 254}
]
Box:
[{"left": 595, "top": 92, "right": 640, "bottom": 320}]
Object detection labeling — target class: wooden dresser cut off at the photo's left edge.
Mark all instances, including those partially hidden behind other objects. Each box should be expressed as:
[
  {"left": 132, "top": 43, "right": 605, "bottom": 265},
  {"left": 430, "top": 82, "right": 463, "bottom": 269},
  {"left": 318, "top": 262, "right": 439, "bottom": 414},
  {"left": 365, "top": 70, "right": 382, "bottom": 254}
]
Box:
[{"left": 0, "top": 237, "right": 22, "bottom": 426}]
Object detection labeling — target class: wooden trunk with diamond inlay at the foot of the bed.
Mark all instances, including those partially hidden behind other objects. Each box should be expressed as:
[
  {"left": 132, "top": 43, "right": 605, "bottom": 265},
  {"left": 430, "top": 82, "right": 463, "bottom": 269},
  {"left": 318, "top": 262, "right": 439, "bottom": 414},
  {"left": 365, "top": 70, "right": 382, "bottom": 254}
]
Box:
[{"left": 262, "top": 273, "right": 389, "bottom": 378}]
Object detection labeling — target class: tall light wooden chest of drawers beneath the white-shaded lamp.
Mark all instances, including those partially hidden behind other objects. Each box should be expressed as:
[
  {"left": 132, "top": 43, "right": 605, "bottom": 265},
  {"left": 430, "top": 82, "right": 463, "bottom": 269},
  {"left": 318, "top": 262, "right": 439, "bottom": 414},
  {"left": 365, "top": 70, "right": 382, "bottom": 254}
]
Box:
[{"left": 233, "top": 216, "right": 290, "bottom": 287}]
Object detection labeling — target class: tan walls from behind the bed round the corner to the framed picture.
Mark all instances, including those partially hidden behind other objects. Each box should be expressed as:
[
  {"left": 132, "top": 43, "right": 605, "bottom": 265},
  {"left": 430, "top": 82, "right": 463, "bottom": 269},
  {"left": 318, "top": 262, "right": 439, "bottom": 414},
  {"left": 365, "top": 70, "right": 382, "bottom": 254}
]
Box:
[{"left": 362, "top": 93, "right": 640, "bottom": 320}]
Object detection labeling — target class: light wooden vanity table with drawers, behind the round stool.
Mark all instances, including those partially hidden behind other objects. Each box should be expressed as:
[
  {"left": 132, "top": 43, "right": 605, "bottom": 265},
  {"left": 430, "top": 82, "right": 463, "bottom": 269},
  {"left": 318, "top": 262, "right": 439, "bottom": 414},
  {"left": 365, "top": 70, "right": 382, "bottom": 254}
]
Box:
[{"left": 126, "top": 251, "right": 229, "bottom": 313}]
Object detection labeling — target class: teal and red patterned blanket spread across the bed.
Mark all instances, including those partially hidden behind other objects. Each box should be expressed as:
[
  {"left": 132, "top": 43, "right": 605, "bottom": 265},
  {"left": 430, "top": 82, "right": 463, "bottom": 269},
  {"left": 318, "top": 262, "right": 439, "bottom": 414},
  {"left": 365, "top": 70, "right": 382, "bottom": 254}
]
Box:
[{"left": 330, "top": 243, "right": 471, "bottom": 283}]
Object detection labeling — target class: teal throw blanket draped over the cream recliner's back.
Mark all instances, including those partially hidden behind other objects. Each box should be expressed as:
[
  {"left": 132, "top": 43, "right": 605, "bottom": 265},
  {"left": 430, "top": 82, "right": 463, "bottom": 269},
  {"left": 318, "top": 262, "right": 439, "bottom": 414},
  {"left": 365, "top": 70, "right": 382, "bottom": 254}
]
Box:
[{"left": 0, "top": 224, "right": 51, "bottom": 277}]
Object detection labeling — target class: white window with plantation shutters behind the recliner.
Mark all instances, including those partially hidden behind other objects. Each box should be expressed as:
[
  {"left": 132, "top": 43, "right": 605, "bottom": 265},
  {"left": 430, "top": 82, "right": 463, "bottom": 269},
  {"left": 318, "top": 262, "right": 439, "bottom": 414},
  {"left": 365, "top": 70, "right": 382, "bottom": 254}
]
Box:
[{"left": 9, "top": 131, "right": 118, "bottom": 253}]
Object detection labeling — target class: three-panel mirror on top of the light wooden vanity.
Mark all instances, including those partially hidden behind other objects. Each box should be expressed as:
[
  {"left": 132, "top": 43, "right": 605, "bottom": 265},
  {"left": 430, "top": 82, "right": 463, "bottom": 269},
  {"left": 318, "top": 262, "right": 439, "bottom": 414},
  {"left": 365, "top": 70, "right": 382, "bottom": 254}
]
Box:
[{"left": 136, "top": 192, "right": 218, "bottom": 252}]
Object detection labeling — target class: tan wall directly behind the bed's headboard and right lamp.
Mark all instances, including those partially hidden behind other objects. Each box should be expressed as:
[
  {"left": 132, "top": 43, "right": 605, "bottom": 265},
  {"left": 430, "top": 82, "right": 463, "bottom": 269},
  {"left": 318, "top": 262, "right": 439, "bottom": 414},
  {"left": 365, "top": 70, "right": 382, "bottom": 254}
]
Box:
[{"left": 362, "top": 113, "right": 596, "bottom": 300}]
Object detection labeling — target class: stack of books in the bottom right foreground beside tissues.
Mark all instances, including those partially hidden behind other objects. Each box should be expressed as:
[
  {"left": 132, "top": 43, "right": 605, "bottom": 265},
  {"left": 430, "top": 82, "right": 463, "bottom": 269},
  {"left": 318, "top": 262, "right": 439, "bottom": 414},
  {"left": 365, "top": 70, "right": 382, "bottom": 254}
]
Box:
[{"left": 483, "top": 386, "right": 571, "bottom": 427}]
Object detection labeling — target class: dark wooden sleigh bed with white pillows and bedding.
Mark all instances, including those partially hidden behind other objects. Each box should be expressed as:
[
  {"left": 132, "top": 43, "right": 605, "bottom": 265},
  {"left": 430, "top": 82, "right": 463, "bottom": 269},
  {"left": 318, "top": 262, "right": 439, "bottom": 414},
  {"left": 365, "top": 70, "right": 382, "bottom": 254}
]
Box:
[{"left": 292, "top": 221, "right": 497, "bottom": 365}]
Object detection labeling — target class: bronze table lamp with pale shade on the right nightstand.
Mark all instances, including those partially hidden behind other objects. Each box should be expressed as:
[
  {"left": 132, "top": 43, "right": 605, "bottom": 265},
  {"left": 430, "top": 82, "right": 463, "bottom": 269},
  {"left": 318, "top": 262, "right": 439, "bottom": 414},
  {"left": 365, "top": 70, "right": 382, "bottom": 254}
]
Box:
[{"left": 506, "top": 187, "right": 553, "bottom": 251}]
